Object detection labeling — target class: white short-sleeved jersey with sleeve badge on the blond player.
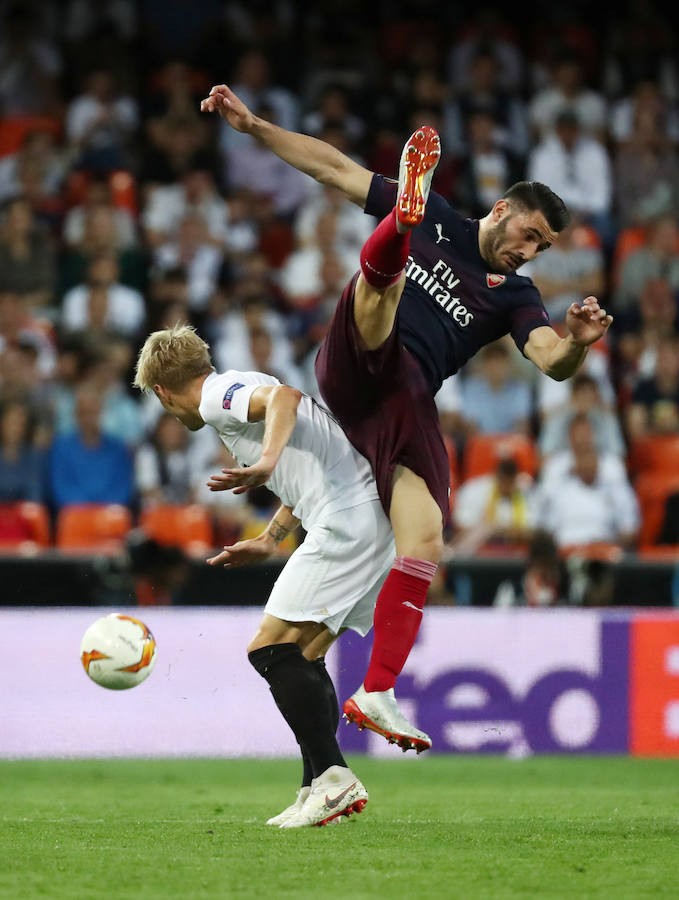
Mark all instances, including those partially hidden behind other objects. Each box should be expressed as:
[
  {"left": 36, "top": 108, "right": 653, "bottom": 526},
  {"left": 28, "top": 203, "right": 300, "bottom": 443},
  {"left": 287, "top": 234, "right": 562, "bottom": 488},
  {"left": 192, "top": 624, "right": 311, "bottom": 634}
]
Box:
[{"left": 199, "top": 370, "right": 379, "bottom": 531}]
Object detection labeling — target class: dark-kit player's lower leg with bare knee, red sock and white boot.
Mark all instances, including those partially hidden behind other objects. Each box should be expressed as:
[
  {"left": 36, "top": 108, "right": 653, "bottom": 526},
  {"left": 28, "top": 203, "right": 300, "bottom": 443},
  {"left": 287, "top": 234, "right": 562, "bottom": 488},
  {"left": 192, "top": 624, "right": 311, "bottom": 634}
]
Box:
[{"left": 344, "top": 466, "right": 443, "bottom": 753}]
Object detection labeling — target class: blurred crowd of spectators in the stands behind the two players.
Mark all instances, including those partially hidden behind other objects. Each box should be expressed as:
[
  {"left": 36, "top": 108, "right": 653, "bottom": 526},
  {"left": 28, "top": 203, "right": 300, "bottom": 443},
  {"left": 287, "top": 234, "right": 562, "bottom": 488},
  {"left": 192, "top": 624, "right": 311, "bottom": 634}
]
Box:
[{"left": 0, "top": 0, "right": 679, "bottom": 596}]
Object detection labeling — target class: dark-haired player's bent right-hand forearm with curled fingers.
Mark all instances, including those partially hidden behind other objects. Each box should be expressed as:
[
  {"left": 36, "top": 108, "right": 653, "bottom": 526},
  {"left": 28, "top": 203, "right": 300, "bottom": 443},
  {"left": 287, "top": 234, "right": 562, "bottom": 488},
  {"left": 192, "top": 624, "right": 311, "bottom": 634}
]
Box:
[{"left": 523, "top": 297, "right": 613, "bottom": 381}]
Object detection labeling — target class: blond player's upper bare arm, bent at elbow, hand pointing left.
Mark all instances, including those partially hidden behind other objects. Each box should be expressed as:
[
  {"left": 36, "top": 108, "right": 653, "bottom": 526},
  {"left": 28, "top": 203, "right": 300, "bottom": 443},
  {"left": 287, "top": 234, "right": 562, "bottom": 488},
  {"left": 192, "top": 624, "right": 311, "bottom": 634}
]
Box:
[{"left": 207, "top": 384, "right": 302, "bottom": 494}]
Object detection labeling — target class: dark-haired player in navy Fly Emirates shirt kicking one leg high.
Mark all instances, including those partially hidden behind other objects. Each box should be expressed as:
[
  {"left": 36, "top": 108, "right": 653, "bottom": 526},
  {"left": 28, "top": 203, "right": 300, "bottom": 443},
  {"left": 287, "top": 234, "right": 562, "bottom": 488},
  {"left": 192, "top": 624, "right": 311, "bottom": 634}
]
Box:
[{"left": 201, "top": 85, "right": 613, "bottom": 752}]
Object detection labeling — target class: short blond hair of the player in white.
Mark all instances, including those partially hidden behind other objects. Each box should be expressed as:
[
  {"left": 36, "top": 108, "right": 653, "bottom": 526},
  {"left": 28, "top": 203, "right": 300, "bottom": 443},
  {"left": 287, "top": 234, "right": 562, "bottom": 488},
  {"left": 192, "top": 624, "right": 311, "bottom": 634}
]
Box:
[{"left": 132, "top": 325, "right": 214, "bottom": 391}]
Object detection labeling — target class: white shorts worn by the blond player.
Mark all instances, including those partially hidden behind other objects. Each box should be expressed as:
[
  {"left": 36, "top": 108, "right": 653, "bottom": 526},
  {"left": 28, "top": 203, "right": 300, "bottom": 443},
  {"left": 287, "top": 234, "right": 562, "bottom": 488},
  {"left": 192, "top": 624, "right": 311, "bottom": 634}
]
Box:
[{"left": 264, "top": 500, "right": 395, "bottom": 635}]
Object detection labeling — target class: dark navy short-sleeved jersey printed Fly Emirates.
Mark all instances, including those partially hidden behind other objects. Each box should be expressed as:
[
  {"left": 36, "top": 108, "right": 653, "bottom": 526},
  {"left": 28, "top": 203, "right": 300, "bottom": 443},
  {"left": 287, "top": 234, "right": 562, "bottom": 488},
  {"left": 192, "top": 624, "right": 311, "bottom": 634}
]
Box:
[{"left": 365, "top": 175, "right": 549, "bottom": 394}]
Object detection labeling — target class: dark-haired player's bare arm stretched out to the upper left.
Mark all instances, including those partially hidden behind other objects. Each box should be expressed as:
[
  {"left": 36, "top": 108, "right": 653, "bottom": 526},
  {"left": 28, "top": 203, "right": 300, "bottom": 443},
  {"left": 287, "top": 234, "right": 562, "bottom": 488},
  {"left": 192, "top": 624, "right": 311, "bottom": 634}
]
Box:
[{"left": 200, "top": 84, "right": 373, "bottom": 206}]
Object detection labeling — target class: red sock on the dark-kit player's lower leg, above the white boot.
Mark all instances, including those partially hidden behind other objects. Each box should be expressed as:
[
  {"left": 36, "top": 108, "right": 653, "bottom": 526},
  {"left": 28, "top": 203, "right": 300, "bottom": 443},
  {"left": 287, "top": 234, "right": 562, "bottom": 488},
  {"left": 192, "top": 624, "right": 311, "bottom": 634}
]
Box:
[{"left": 363, "top": 556, "right": 436, "bottom": 691}]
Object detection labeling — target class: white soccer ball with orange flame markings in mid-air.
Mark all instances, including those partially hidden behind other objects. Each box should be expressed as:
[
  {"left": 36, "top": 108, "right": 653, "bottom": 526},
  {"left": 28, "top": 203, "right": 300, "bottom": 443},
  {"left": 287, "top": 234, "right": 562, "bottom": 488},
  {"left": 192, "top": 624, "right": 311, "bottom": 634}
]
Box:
[{"left": 80, "top": 613, "right": 156, "bottom": 691}]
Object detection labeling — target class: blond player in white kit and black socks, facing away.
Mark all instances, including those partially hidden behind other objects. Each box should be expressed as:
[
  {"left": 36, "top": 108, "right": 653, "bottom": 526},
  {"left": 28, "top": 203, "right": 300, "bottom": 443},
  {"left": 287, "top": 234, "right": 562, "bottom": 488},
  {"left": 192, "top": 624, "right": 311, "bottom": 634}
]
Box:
[{"left": 134, "top": 325, "right": 431, "bottom": 828}]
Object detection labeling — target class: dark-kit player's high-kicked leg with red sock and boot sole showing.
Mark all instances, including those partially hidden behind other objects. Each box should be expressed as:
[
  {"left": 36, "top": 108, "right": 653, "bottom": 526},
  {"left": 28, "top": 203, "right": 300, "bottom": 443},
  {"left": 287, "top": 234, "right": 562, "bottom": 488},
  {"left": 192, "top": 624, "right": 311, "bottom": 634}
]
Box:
[{"left": 354, "top": 125, "right": 441, "bottom": 350}]
